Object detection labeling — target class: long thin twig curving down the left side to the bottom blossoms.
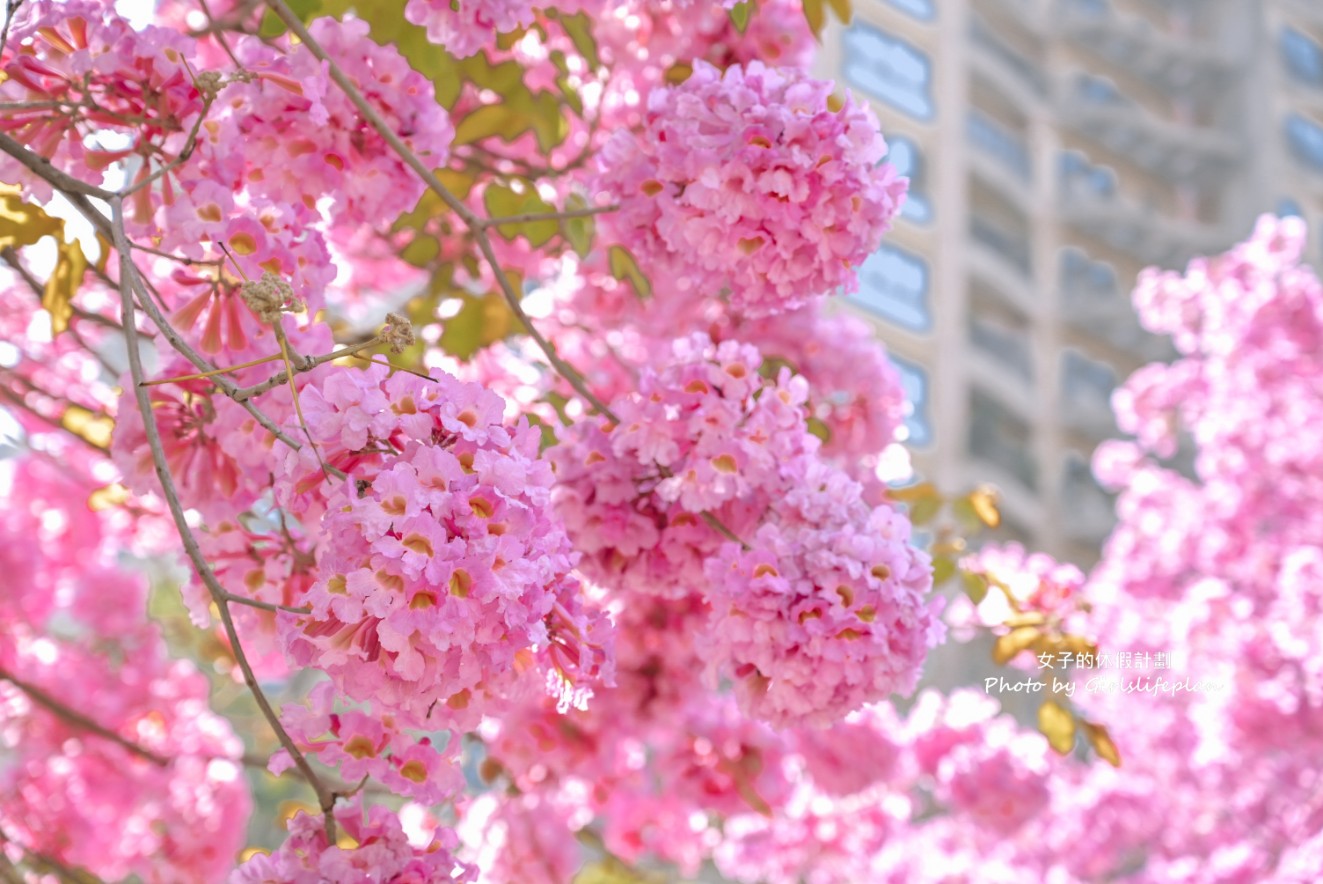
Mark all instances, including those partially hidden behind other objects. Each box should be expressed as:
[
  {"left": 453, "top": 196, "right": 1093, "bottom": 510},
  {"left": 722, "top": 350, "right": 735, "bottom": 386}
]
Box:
[{"left": 110, "top": 196, "right": 336, "bottom": 844}]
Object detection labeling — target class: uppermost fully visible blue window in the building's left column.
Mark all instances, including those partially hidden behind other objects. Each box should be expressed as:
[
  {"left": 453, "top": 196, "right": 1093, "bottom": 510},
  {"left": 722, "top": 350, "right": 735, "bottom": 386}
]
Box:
[{"left": 843, "top": 21, "right": 933, "bottom": 120}]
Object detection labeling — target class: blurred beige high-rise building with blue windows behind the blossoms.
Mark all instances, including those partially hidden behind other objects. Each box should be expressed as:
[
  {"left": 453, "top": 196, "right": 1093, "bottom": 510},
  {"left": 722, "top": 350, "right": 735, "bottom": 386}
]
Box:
[{"left": 818, "top": 0, "right": 1323, "bottom": 564}]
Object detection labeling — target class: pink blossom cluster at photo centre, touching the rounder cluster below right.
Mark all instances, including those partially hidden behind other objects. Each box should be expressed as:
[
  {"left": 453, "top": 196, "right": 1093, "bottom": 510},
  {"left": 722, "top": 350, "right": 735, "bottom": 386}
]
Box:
[{"left": 550, "top": 335, "right": 818, "bottom": 596}]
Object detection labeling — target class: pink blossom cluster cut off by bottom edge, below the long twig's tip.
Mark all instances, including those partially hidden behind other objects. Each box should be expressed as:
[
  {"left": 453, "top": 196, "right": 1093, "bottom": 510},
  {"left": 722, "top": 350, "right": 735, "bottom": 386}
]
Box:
[{"left": 229, "top": 801, "right": 478, "bottom": 884}]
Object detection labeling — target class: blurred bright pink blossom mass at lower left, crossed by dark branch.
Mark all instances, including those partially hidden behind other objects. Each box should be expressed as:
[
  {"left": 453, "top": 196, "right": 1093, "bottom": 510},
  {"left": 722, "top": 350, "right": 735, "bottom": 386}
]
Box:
[{"left": 0, "top": 460, "right": 250, "bottom": 880}]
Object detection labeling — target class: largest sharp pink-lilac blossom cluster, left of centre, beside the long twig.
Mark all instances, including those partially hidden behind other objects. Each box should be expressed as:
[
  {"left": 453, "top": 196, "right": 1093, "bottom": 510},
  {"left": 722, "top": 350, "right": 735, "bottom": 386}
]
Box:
[{"left": 283, "top": 365, "right": 605, "bottom": 727}]
